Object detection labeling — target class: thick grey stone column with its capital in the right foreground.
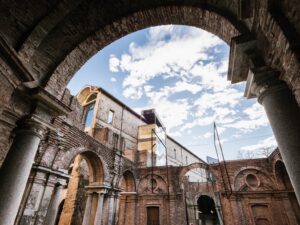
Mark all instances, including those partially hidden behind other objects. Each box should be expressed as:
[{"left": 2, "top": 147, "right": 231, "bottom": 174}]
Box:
[{"left": 248, "top": 68, "right": 300, "bottom": 203}]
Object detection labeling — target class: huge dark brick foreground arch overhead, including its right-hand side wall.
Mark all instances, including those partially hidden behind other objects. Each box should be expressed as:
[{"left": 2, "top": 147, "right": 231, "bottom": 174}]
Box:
[{"left": 1, "top": 0, "right": 300, "bottom": 102}]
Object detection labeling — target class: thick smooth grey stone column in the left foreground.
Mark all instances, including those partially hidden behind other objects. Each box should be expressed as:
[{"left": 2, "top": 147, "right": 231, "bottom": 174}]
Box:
[{"left": 0, "top": 119, "right": 46, "bottom": 225}]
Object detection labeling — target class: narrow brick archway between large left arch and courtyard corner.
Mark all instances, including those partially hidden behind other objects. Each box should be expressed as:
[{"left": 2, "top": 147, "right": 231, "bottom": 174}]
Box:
[{"left": 117, "top": 170, "right": 136, "bottom": 225}]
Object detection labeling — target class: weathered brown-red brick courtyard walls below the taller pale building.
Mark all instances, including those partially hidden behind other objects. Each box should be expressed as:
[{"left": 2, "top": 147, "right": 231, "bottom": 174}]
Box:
[{"left": 10, "top": 86, "right": 300, "bottom": 225}]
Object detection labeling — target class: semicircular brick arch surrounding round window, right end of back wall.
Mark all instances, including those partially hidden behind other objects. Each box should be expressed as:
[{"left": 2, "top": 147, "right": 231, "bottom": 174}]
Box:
[{"left": 233, "top": 166, "right": 274, "bottom": 191}]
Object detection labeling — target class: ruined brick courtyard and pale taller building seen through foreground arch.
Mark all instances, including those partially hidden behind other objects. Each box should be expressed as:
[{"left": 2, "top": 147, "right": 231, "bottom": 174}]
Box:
[{"left": 7, "top": 86, "right": 300, "bottom": 225}]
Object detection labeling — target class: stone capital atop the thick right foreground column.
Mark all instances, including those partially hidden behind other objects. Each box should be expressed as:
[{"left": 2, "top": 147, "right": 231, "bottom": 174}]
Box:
[{"left": 244, "top": 67, "right": 288, "bottom": 104}]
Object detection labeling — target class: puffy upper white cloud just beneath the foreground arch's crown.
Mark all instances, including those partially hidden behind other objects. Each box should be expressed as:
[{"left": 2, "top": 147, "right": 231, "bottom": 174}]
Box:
[{"left": 110, "top": 25, "right": 223, "bottom": 98}]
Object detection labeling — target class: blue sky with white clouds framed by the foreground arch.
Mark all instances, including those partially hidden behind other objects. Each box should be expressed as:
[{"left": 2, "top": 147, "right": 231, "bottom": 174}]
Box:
[{"left": 68, "top": 25, "right": 276, "bottom": 159}]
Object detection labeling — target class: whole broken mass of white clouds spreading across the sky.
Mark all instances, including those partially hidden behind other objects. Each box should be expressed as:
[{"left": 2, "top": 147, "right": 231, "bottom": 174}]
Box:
[{"left": 109, "top": 25, "right": 268, "bottom": 151}]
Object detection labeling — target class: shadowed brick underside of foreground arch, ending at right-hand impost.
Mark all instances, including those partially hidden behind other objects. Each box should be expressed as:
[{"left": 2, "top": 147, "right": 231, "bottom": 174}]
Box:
[{"left": 0, "top": 0, "right": 249, "bottom": 98}]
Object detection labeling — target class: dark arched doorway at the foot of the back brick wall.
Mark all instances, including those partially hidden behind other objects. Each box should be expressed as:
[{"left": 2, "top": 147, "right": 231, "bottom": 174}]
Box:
[{"left": 197, "top": 195, "right": 220, "bottom": 225}]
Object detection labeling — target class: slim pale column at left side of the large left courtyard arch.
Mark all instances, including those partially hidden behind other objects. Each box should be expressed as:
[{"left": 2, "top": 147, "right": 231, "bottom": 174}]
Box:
[{"left": 44, "top": 183, "right": 64, "bottom": 225}]
